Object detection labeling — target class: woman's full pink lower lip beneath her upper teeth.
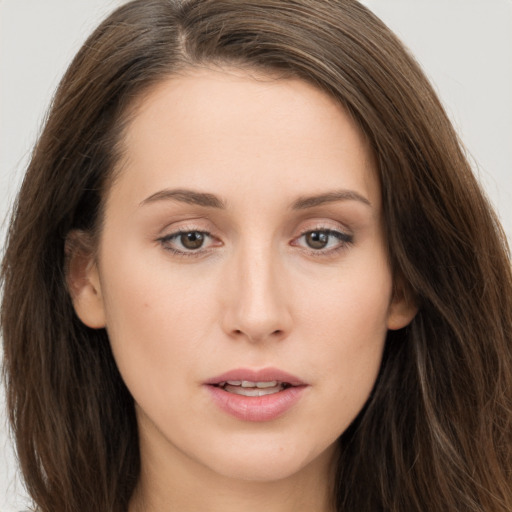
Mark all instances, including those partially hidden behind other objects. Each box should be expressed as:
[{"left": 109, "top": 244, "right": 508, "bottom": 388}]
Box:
[{"left": 206, "top": 385, "right": 306, "bottom": 421}]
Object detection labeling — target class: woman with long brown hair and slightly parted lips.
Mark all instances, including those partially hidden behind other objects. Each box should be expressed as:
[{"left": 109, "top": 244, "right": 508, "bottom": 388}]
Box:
[{"left": 2, "top": 0, "right": 512, "bottom": 512}]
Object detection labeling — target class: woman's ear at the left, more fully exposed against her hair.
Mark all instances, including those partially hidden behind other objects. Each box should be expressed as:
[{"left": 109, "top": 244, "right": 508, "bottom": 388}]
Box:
[{"left": 65, "top": 230, "right": 105, "bottom": 329}]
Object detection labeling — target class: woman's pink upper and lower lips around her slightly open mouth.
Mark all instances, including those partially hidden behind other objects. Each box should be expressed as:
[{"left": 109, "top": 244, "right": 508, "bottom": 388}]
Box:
[{"left": 204, "top": 368, "right": 308, "bottom": 422}]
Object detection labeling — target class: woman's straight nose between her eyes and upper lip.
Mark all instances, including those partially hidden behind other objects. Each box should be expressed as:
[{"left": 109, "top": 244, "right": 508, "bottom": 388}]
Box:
[{"left": 222, "top": 243, "right": 292, "bottom": 343}]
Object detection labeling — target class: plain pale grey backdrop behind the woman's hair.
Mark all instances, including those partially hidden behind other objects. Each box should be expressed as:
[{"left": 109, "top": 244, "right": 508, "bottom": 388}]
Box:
[{"left": 0, "top": 0, "right": 512, "bottom": 512}]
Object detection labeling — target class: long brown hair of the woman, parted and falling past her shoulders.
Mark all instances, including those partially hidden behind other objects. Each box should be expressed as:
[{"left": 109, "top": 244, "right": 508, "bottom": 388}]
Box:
[{"left": 1, "top": 0, "right": 512, "bottom": 512}]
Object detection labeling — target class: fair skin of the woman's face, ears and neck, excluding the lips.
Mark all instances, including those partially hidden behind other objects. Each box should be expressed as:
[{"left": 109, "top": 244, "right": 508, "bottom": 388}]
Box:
[{"left": 69, "top": 68, "right": 415, "bottom": 512}]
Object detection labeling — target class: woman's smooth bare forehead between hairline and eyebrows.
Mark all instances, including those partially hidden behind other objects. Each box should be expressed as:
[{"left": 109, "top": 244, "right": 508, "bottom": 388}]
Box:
[{"left": 111, "top": 68, "right": 380, "bottom": 212}]
